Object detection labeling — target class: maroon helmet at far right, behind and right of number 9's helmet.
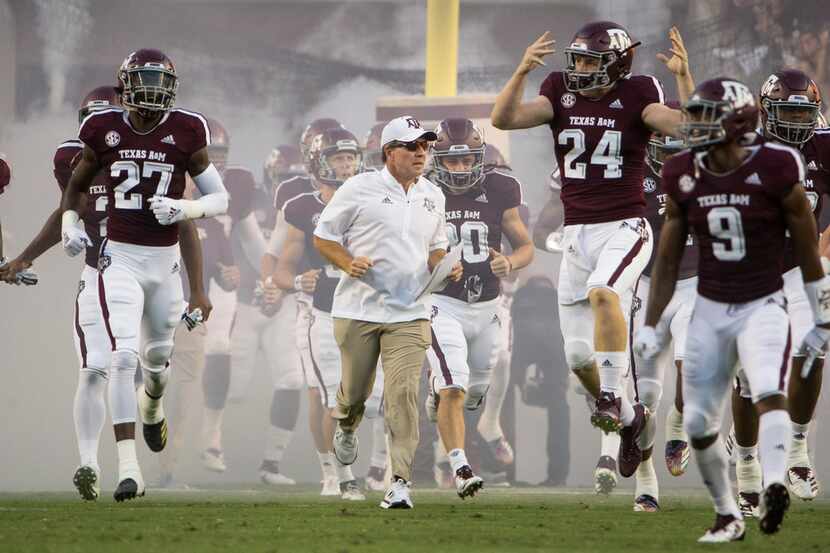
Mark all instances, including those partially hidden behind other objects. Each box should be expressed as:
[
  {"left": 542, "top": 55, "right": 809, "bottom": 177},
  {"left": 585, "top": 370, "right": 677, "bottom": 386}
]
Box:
[{"left": 760, "top": 69, "right": 821, "bottom": 146}]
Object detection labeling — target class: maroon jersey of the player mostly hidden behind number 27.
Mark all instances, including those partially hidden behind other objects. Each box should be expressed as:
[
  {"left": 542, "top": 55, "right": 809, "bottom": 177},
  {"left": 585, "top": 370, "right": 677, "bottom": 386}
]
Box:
[{"left": 53, "top": 140, "right": 108, "bottom": 268}]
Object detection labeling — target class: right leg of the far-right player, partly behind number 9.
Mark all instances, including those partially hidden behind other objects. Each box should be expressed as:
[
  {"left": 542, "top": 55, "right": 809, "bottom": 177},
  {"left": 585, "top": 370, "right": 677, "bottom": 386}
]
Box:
[{"left": 784, "top": 269, "right": 824, "bottom": 501}]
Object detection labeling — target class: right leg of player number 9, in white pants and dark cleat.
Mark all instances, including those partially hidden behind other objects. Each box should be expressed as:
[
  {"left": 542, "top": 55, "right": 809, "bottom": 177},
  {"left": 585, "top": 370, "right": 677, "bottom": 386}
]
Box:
[{"left": 738, "top": 294, "right": 792, "bottom": 534}]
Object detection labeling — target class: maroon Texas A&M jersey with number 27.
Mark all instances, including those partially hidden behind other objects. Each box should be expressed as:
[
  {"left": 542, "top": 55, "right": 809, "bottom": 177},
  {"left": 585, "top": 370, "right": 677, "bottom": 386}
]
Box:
[{"left": 78, "top": 108, "right": 210, "bottom": 246}]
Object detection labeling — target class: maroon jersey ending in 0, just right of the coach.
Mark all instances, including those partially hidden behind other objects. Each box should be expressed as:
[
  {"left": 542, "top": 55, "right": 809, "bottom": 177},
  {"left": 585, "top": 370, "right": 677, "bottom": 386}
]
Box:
[{"left": 438, "top": 171, "right": 522, "bottom": 303}]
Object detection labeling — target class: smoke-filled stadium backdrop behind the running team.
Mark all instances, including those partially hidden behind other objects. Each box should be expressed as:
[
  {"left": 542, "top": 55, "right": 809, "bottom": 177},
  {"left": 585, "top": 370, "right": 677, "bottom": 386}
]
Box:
[{"left": 0, "top": 0, "right": 830, "bottom": 491}]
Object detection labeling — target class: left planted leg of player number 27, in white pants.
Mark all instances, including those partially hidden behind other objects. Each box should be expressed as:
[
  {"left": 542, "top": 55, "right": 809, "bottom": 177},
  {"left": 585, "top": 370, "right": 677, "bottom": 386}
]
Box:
[{"left": 98, "top": 252, "right": 144, "bottom": 502}]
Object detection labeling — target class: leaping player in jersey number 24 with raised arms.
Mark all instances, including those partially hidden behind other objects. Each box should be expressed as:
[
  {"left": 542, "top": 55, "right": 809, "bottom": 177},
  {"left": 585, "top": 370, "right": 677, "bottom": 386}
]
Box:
[{"left": 491, "top": 21, "right": 681, "bottom": 476}]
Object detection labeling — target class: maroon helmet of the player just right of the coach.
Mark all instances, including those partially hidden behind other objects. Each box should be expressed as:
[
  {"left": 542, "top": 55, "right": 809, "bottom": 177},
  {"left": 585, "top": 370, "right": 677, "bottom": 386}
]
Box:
[{"left": 431, "top": 117, "right": 486, "bottom": 194}]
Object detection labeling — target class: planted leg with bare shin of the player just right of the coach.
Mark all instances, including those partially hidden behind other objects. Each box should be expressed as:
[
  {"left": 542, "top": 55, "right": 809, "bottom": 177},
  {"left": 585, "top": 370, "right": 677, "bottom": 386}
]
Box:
[{"left": 427, "top": 298, "right": 483, "bottom": 499}]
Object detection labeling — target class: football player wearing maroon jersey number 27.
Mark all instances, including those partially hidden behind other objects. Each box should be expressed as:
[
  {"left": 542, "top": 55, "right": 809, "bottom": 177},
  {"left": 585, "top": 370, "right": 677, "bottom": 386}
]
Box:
[{"left": 61, "top": 49, "right": 228, "bottom": 499}]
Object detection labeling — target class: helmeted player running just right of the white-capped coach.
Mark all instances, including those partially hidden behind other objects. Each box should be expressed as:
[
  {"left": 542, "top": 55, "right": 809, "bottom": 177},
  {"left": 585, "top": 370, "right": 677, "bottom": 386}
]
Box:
[{"left": 426, "top": 118, "right": 533, "bottom": 499}]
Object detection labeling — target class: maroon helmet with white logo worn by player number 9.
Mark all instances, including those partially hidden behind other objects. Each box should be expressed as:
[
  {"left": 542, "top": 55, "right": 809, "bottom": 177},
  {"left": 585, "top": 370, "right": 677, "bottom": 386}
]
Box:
[{"left": 680, "top": 77, "right": 758, "bottom": 149}]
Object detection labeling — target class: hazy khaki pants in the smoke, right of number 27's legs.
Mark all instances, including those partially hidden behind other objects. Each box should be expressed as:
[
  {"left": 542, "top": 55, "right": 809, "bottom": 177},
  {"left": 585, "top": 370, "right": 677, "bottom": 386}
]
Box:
[{"left": 159, "top": 323, "right": 207, "bottom": 473}]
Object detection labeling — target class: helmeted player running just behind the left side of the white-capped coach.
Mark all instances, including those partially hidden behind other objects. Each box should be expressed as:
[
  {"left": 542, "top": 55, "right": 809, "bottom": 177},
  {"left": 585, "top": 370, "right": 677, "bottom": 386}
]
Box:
[{"left": 274, "top": 127, "right": 386, "bottom": 500}]
